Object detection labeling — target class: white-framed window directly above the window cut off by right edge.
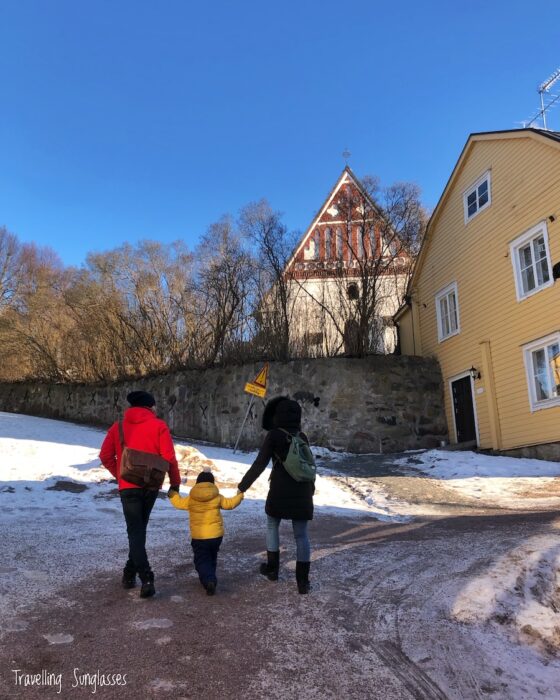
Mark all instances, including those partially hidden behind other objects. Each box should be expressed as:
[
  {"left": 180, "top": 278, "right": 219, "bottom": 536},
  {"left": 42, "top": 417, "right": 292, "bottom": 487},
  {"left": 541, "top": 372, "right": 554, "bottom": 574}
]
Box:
[{"left": 510, "top": 221, "right": 553, "bottom": 301}]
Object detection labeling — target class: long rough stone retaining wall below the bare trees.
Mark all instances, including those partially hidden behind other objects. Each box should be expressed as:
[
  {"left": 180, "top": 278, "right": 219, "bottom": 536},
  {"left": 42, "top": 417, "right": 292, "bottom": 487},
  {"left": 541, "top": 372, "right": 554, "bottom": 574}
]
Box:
[{"left": 0, "top": 356, "right": 448, "bottom": 453}]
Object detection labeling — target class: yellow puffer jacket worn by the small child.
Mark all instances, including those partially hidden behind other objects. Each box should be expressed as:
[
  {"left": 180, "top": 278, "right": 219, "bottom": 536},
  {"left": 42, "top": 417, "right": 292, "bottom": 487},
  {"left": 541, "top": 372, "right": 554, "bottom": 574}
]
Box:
[{"left": 171, "top": 481, "right": 243, "bottom": 540}]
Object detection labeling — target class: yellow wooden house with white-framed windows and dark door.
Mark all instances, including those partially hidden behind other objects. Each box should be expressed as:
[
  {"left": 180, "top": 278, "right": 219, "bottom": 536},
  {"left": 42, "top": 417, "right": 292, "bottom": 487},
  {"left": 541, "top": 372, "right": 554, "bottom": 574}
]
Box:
[{"left": 395, "top": 129, "right": 560, "bottom": 459}]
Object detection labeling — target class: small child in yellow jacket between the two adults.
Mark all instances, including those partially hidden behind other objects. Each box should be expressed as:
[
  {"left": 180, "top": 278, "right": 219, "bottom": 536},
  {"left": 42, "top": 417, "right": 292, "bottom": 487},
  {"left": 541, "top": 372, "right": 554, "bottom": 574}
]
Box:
[{"left": 169, "top": 470, "right": 243, "bottom": 595}]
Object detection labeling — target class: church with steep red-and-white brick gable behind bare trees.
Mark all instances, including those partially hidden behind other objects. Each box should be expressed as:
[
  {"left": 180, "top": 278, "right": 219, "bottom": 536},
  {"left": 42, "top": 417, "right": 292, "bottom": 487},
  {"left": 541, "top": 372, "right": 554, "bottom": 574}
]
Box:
[{"left": 285, "top": 166, "right": 412, "bottom": 356}]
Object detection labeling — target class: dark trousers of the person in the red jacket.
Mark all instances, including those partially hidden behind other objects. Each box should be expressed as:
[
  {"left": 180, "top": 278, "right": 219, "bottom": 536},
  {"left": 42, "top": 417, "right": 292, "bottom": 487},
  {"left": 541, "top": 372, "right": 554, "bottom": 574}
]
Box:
[{"left": 120, "top": 489, "right": 158, "bottom": 581}]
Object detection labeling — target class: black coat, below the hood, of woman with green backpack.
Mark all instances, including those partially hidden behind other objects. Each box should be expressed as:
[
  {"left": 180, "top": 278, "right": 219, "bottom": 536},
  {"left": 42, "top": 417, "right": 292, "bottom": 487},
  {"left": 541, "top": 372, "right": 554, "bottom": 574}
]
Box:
[{"left": 239, "top": 428, "right": 315, "bottom": 520}]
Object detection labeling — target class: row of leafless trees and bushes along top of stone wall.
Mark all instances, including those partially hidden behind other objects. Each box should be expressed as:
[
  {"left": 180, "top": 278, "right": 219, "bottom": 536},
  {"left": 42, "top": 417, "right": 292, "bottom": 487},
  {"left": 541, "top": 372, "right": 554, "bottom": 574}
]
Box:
[{"left": 0, "top": 178, "right": 426, "bottom": 381}]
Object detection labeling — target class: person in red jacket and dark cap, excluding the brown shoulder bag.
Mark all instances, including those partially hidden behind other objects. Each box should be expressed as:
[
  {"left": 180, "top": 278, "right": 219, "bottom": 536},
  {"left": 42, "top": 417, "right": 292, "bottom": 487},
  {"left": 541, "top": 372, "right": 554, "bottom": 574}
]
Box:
[{"left": 99, "top": 391, "right": 181, "bottom": 598}]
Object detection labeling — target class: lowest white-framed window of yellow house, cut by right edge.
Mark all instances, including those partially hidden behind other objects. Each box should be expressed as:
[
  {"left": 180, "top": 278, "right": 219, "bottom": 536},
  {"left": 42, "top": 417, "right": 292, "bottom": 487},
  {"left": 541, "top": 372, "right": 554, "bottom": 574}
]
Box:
[{"left": 523, "top": 333, "right": 560, "bottom": 411}]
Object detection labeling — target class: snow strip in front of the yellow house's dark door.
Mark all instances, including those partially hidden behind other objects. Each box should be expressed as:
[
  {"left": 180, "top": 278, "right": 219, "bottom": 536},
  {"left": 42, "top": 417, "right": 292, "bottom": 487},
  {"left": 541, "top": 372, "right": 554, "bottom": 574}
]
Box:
[{"left": 397, "top": 450, "right": 560, "bottom": 510}]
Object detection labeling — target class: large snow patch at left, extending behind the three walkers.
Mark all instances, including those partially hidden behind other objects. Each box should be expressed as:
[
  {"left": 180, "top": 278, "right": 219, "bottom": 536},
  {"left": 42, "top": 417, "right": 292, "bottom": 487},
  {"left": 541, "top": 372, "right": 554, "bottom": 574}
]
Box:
[{"left": 0, "top": 412, "right": 394, "bottom": 632}]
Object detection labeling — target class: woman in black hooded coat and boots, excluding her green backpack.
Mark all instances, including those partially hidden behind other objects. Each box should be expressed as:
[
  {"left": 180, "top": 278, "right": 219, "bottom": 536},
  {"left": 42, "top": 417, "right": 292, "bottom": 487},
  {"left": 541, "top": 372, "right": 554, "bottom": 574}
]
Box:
[{"left": 238, "top": 396, "right": 315, "bottom": 593}]
